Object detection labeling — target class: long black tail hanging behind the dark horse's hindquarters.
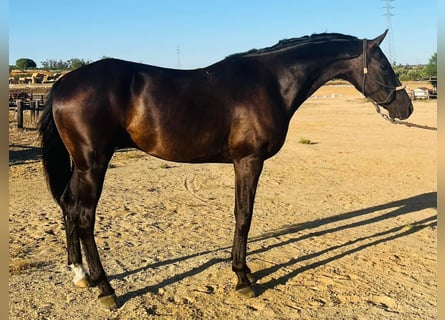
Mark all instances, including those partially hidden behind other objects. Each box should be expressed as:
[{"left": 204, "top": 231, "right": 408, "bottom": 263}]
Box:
[{"left": 38, "top": 82, "right": 72, "bottom": 204}]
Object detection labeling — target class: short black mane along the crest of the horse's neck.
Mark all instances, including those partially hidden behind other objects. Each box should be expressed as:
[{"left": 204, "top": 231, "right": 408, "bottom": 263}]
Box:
[{"left": 227, "top": 33, "right": 358, "bottom": 58}]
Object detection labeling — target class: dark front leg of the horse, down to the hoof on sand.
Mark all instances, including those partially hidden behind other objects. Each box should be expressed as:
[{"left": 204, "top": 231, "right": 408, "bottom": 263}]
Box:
[{"left": 232, "top": 157, "right": 263, "bottom": 297}]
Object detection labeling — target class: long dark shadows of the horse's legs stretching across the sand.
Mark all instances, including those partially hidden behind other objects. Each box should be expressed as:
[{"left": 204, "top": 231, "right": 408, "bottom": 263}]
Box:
[{"left": 109, "top": 192, "right": 437, "bottom": 304}]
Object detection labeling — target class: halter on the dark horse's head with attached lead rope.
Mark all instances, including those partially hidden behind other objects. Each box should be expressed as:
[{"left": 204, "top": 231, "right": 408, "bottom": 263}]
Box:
[{"left": 362, "top": 39, "right": 437, "bottom": 131}]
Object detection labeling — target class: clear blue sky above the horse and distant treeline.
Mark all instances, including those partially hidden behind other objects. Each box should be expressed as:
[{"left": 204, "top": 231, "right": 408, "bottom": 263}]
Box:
[{"left": 9, "top": 0, "right": 438, "bottom": 69}]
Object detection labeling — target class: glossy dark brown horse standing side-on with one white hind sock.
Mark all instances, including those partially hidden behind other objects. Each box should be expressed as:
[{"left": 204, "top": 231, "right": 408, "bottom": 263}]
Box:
[{"left": 39, "top": 31, "right": 413, "bottom": 307}]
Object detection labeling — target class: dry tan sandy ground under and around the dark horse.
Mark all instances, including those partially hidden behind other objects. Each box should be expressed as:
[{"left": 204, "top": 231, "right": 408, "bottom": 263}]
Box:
[{"left": 9, "top": 87, "right": 437, "bottom": 320}]
